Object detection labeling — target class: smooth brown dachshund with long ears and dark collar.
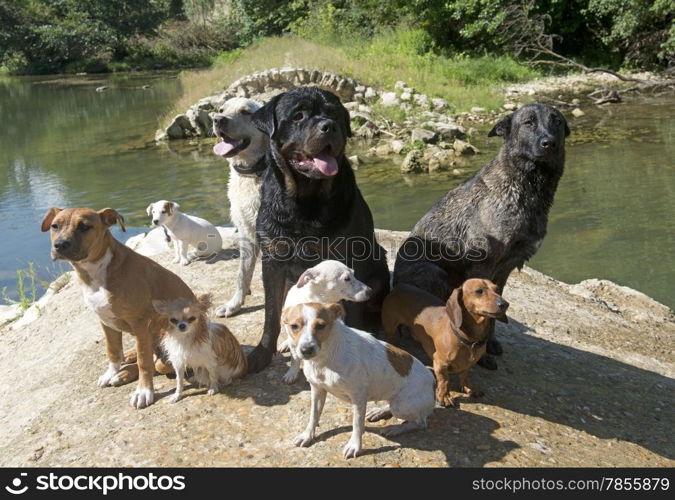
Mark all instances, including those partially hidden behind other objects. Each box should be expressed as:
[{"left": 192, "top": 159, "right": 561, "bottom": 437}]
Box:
[{"left": 382, "top": 278, "right": 509, "bottom": 406}]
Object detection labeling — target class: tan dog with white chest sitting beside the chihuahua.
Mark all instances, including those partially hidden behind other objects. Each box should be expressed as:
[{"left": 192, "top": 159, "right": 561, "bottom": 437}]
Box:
[{"left": 42, "top": 208, "right": 196, "bottom": 408}]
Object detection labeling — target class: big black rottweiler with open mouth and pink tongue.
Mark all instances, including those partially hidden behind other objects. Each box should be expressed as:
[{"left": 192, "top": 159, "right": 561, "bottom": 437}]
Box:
[{"left": 248, "top": 87, "right": 389, "bottom": 372}]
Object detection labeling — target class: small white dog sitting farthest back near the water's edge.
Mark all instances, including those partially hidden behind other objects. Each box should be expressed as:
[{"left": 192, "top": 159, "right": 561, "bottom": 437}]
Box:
[{"left": 146, "top": 200, "right": 223, "bottom": 266}]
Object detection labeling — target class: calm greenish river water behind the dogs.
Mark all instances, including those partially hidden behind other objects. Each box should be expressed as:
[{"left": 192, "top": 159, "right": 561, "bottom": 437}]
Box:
[{"left": 0, "top": 73, "right": 675, "bottom": 307}]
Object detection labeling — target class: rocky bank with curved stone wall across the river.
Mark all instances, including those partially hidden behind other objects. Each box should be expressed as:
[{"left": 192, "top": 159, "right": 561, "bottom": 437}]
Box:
[{"left": 155, "top": 68, "right": 675, "bottom": 174}]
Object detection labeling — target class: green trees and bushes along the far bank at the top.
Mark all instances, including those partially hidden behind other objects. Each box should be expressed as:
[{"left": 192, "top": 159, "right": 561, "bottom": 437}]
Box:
[{"left": 0, "top": 0, "right": 675, "bottom": 74}]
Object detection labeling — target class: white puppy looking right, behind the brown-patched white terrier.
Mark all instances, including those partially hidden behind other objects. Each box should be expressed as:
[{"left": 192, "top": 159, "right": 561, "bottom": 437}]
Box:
[{"left": 279, "top": 260, "right": 372, "bottom": 384}]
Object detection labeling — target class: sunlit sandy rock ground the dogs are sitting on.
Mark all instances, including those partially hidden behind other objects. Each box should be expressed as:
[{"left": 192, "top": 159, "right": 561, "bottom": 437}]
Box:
[{"left": 0, "top": 232, "right": 675, "bottom": 467}]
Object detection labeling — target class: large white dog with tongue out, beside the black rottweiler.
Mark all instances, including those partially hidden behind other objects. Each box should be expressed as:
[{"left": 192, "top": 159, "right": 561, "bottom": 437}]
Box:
[{"left": 213, "top": 97, "right": 268, "bottom": 317}]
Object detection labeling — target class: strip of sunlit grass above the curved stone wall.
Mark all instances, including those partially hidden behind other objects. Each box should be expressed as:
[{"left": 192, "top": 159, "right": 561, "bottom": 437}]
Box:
[{"left": 161, "top": 28, "right": 538, "bottom": 124}]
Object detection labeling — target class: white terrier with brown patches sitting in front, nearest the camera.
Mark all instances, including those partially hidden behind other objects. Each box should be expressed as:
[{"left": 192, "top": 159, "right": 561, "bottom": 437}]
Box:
[{"left": 282, "top": 303, "right": 435, "bottom": 458}]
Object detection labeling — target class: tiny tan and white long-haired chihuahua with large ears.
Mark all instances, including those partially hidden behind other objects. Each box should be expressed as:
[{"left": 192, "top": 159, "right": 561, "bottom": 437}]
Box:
[{"left": 152, "top": 295, "right": 247, "bottom": 403}]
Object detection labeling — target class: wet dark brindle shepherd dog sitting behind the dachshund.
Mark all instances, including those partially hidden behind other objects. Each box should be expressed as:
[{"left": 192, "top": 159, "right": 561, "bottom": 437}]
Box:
[{"left": 394, "top": 104, "right": 570, "bottom": 369}]
